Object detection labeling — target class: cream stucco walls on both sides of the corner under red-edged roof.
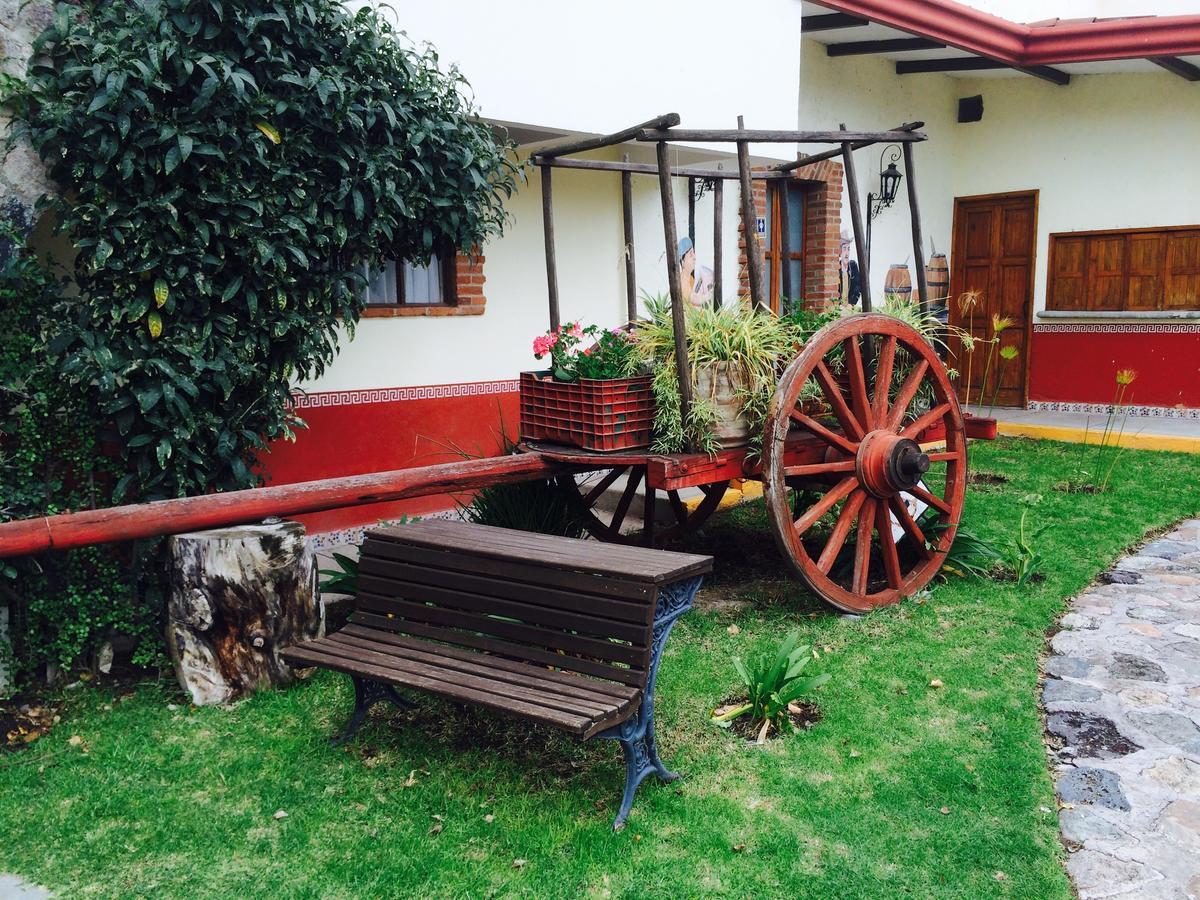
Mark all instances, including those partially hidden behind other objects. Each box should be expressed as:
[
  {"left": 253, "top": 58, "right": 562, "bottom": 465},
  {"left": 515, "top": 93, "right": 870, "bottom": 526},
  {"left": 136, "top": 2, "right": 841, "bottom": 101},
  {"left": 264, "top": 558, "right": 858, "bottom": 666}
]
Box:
[{"left": 800, "top": 46, "right": 1200, "bottom": 321}]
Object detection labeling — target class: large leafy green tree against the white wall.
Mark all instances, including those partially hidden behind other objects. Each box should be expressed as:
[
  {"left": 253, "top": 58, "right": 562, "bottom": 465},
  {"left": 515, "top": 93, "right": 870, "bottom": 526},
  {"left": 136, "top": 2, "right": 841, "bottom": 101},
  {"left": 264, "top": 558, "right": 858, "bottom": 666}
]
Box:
[{"left": 16, "top": 0, "right": 517, "bottom": 499}]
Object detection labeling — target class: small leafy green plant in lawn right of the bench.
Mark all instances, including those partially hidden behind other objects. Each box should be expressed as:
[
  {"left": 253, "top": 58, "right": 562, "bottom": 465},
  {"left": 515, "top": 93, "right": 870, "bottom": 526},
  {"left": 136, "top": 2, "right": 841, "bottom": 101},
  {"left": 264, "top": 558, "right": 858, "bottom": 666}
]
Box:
[{"left": 712, "top": 631, "right": 829, "bottom": 744}]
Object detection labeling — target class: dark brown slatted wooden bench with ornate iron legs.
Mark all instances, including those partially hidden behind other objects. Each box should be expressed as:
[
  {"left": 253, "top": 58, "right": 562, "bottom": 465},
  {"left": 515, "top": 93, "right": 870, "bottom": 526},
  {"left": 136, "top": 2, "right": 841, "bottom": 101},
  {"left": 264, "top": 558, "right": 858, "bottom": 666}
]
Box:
[{"left": 282, "top": 520, "right": 713, "bottom": 828}]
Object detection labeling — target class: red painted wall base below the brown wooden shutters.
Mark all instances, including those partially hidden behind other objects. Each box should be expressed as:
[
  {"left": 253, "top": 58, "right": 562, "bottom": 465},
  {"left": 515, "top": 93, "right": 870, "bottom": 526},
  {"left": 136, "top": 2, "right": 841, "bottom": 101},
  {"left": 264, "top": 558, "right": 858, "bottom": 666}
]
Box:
[{"left": 1030, "top": 324, "right": 1200, "bottom": 407}]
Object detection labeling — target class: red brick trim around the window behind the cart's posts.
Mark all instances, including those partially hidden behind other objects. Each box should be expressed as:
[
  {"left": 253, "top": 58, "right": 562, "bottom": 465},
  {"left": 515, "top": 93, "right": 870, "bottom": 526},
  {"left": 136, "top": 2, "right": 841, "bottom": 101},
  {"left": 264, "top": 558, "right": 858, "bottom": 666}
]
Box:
[{"left": 738, "top": 160, "right": 842, "bottom": 310}]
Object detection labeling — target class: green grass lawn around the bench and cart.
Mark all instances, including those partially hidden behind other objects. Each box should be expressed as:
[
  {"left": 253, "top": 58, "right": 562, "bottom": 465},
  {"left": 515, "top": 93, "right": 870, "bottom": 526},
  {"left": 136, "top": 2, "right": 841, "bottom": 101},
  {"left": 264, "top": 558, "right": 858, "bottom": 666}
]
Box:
[{"left": 0, "top": 440, "right": 1200, "bottom": 898}]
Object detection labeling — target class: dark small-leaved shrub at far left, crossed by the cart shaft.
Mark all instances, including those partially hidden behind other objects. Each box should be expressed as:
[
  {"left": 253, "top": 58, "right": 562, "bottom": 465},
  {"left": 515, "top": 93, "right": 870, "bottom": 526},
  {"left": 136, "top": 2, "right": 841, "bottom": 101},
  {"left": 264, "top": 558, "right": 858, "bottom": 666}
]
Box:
[{"left": 0, "top": 228, "right": 160, "bottom": 686}]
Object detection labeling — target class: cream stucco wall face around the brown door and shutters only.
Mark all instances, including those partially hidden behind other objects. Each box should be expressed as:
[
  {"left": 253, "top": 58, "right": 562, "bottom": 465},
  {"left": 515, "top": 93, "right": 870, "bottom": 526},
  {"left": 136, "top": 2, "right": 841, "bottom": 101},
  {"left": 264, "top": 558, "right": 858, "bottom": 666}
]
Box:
[{"left": 950, "top": 72, "right": 1200, "bottom": 311}]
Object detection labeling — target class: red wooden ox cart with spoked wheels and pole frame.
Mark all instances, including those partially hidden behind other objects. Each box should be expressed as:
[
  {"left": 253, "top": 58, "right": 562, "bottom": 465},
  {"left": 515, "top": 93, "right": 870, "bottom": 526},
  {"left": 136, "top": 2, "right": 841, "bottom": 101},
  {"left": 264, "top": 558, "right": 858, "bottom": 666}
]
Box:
[{"left": 0, "top": 115, "right": 990, "bottom": 612}]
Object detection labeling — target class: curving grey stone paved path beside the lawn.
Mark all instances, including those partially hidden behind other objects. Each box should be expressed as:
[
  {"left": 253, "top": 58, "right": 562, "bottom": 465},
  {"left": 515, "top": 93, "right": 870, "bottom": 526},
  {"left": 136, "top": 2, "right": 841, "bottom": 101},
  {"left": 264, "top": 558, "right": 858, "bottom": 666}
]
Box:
[{"left": 1042, "top": 520, "right": 1200, "bottom": 900}]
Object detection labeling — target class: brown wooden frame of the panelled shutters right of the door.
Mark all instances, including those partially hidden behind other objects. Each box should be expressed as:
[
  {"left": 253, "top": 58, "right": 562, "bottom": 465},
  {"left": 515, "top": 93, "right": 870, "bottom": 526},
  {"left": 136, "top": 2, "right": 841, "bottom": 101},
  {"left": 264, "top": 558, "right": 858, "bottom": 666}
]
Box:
[{"left": 1045, "top": 224, "right": 1200, "bottom": 317}]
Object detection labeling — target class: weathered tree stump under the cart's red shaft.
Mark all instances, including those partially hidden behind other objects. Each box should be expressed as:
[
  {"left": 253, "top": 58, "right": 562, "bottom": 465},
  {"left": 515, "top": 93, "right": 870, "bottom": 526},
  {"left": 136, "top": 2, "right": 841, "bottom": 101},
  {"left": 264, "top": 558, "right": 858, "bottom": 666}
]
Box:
[{"left": 167, "top": 520, "right": 325, "bottom": 706}]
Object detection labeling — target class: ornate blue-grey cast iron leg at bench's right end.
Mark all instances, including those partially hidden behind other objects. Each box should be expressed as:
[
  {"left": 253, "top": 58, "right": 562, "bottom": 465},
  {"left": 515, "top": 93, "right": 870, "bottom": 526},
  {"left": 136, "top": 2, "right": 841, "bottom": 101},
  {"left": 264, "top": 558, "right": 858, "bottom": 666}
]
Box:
[{"left": 596, "top": 577, "right": 702, "bottom": 832}]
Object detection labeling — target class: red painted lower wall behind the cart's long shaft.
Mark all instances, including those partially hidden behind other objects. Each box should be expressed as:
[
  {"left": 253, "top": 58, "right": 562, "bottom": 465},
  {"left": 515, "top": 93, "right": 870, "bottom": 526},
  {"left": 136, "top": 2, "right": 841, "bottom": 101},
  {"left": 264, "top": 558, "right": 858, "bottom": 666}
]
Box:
[{"left": 260, "top": 382, "right": 518, "bottom": 534}]
